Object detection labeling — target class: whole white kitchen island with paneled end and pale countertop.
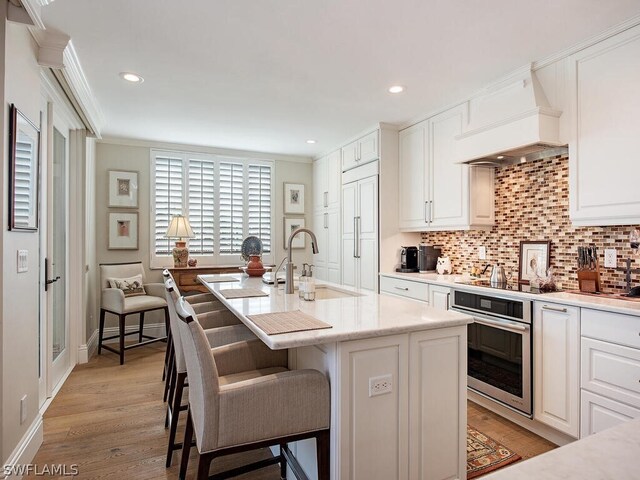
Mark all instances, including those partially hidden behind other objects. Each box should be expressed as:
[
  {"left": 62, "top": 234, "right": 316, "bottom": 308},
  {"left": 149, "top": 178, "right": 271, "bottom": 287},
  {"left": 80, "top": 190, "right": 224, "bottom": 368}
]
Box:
[{"left": 199, "top": 274, "right": 472, "bottom": 480}]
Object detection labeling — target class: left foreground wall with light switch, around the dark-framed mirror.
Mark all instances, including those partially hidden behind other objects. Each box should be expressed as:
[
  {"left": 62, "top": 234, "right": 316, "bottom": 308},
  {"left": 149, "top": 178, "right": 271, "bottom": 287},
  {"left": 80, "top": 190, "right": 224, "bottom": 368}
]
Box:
[{"left": 0, "top": 19, "right": 40, "bottom": 461}]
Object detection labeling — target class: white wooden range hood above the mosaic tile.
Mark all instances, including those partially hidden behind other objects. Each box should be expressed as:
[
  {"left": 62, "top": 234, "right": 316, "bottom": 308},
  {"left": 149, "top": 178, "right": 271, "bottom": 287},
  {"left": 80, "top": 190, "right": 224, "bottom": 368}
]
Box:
[{"left": 456, "top": 65, "right": 566, "bottom": 166}]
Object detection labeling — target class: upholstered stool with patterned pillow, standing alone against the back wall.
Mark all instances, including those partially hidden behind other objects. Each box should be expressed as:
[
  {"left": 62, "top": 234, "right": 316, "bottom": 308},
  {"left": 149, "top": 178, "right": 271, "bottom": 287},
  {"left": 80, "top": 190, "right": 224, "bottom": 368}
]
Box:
[{"left": 98, "top": 262, "right": 169, "bottom": 365}]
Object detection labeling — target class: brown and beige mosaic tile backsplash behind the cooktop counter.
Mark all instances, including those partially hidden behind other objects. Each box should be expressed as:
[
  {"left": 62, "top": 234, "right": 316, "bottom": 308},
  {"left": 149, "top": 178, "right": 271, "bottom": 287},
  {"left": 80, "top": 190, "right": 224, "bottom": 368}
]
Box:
[{"left": 422, "top": 157, "right": 640, "bottom": 293}]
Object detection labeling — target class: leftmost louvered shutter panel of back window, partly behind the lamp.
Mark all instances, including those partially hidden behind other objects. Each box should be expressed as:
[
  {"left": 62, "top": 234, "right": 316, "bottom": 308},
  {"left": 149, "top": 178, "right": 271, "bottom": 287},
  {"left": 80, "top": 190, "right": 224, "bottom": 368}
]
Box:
[{"left": 154, "top": 156, "right": 183, "bottom": 255}]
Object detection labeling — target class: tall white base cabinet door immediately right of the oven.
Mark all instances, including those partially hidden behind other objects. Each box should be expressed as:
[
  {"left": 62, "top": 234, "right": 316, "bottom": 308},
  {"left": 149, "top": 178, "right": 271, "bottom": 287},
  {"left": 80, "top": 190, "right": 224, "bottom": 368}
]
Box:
[{"left": 533, "top": 302, "right": 580, "bottom": 438}]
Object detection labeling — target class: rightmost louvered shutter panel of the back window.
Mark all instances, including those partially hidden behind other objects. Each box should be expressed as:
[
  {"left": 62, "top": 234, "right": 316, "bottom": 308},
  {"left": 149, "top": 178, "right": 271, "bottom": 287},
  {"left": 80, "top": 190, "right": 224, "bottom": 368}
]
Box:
[{"left": 247, "top": 165, "right": 271, "bottom": 253}]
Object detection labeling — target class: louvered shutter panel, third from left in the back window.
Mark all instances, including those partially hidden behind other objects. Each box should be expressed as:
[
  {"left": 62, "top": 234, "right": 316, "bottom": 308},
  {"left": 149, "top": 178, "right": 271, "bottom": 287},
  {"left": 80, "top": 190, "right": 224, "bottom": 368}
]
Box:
[{"left": 219, "top": 162, "right": 244, "bottom": 254}]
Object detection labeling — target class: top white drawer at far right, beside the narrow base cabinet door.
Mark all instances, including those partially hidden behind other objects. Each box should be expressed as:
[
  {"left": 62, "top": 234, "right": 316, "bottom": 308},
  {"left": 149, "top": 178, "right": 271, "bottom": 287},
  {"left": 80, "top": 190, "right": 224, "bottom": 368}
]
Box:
[{"left": 581, "top": 308, "right": 640, "bottom": 348}]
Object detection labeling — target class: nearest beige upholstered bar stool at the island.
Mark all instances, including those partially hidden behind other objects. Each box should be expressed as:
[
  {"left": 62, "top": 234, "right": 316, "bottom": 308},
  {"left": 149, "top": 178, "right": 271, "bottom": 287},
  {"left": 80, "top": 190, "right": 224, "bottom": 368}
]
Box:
[{"left": 176, "top": 298, "right": 331, "bottom": 480}]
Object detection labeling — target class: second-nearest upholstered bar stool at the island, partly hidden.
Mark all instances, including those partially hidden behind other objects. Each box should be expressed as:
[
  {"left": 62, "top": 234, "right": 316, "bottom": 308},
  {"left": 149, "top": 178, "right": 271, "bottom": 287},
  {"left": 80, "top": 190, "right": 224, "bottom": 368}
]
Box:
[{"left": 165, "top": 278, "right": 256, "bottom": 467}]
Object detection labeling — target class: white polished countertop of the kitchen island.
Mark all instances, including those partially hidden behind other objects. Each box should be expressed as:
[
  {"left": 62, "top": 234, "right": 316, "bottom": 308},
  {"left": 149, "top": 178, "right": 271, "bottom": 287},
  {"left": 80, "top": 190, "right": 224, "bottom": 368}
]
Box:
[{"left": 198, "top": 273, "right": 473, "bottom": 350}]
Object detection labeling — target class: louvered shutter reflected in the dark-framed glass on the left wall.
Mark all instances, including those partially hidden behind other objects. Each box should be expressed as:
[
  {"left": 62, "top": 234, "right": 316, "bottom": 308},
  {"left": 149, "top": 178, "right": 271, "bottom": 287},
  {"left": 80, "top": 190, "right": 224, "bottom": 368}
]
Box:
[{"left": 14, "top": 136, "right": 37, "bottom": 226}]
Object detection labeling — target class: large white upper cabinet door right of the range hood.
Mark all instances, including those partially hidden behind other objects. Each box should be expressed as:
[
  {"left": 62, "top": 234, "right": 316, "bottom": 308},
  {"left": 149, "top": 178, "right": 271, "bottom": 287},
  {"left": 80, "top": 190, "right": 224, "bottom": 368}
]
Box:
[{"left": 569, "top": 27, "right": 640, "bottom": 225}]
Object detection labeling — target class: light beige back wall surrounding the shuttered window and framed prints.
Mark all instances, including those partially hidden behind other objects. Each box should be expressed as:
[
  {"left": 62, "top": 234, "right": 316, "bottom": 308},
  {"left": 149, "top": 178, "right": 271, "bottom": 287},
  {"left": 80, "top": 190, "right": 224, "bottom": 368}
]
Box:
[{"left": 94, "top": 139, "right": 313, "bottom": 336}]
